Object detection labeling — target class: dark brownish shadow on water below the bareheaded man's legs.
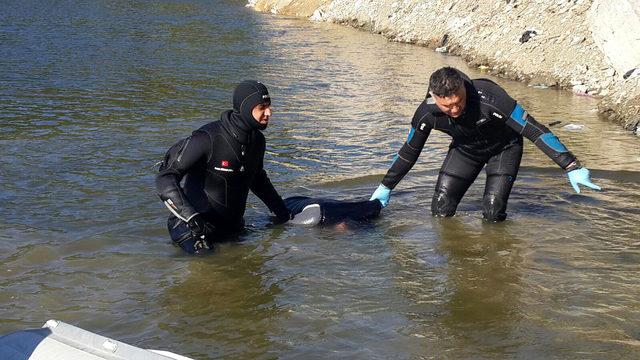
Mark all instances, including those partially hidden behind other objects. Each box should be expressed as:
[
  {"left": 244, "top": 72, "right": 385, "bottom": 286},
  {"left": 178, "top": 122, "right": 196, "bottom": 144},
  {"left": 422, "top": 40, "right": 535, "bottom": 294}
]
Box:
[{"left": 434, "top": 218, "right": 523, "bottom": 356}]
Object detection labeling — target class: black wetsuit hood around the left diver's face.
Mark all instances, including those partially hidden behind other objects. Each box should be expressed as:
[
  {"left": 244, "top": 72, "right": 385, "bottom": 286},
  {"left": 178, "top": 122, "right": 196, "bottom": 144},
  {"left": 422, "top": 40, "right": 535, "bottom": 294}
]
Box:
[{"left": 231, "top": 80, "right": 271, "bottom": 132}]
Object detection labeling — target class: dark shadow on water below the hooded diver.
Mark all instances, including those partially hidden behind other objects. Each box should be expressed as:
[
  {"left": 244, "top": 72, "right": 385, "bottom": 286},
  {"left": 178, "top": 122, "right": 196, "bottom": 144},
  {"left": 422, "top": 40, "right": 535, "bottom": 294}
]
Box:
[{"left": 158, "top": 243, "right": 286, "bottom": 359}]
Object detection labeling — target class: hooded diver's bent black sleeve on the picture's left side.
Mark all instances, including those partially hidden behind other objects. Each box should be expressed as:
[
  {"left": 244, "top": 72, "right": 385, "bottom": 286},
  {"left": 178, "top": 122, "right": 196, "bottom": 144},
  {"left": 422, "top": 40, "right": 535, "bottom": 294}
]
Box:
[{"left": 156, "top": 132, "right": 211, "bottom": 222}]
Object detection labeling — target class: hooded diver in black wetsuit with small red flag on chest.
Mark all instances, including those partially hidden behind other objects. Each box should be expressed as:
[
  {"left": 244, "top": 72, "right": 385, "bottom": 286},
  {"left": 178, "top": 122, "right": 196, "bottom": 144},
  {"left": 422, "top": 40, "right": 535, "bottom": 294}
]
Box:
[{"left": 156, "top": 80, "right": 291, "bottom": 254}]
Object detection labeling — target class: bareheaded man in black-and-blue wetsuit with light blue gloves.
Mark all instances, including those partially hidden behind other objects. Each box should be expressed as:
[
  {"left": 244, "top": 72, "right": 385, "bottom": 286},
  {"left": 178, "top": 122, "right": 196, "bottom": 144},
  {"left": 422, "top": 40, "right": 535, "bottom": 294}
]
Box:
[{"left": 371, "top": 67, "right": 600, "bottom": 221}]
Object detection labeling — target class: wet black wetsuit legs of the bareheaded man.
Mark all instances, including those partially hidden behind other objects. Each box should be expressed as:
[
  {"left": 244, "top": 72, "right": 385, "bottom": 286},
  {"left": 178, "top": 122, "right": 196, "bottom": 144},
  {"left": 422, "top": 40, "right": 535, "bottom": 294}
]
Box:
[{"left": 431, "top": 143, "right": 522, "bottom": 221}]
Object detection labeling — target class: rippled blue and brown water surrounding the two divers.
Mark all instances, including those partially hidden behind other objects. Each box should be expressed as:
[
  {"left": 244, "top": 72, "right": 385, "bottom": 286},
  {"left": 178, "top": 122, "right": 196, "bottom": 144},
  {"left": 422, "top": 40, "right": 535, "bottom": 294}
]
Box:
[{"left": 0, "top": 0, "right": 640, "bottom": 359}]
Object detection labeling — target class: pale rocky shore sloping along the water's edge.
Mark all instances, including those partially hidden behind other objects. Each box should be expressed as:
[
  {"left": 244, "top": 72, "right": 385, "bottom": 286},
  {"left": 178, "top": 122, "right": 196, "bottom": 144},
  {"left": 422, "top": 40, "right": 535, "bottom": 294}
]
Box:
[{"left": 248, "top": 0, "right": 640, "bottom": 135}]
